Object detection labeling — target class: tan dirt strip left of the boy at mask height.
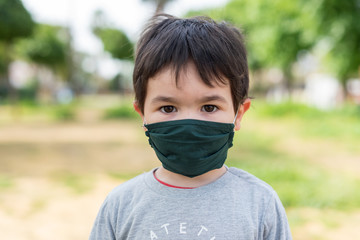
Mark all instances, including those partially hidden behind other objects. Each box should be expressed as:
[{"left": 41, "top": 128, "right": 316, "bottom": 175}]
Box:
[{"left": 0, "top": 121, "right": 158, "bottom": 176}]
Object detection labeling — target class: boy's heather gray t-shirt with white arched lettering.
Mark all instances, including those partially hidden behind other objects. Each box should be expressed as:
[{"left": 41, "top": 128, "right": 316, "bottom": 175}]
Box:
[{"left": 89, "top": 168, "right": 292, "bottom": 240}]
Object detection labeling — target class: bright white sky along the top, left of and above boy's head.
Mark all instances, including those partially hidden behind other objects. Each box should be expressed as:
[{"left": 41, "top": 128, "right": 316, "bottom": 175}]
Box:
[{"left": 23, "top": 0, "right": 228, "bottom": 54}]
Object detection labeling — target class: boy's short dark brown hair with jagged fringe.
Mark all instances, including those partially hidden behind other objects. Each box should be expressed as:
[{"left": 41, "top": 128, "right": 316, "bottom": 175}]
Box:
[{"left": 133, "top": 14, "right": 249, "bottom": 112}]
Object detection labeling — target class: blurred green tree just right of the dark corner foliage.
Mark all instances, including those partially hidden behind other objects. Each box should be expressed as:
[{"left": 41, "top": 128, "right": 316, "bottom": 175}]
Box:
[{"left": 16, "top": 24, "right": 88, "bottom": 99}]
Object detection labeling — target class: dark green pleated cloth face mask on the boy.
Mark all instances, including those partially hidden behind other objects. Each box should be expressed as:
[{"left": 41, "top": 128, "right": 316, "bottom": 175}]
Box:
[{"left": 144, "top": 119, "right": 234, "bottom": 177}]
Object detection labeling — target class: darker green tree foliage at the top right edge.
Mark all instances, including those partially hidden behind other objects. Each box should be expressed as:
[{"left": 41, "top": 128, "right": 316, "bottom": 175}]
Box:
[{"left": 316, "top": 0, "right": 360, "bottom": 84}]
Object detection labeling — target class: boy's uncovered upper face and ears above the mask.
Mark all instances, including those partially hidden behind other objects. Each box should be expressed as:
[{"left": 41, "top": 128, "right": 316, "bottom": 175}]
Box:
[{"left": 134, "top": 61, "right": 250, "bottom": 130}]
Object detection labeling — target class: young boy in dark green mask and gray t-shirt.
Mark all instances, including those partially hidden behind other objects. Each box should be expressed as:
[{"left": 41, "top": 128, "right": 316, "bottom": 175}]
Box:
[{"left": 90, "top": 15, "right": 291, "bottom": 240}]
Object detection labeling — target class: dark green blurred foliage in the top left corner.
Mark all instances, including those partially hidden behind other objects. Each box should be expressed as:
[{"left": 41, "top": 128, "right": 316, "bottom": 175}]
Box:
[{"left": 0, "top": 0, "right": 34, "bottom": 42}]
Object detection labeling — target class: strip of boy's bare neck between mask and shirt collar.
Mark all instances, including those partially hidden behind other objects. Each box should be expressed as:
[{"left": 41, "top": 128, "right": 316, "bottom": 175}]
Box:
[{"left": 155, "top": 166, "right": 227, "bottom": 188}]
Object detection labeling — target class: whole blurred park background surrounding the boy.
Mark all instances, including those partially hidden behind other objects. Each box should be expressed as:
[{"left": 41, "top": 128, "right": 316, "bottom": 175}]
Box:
[{"left": 0, "top": 0, "right": 360, "bottom": 240}]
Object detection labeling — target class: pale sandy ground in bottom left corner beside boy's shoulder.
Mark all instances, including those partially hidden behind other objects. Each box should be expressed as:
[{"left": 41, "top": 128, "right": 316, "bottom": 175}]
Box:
[{"left": 0, "top": 176, "right": 120, "bottom": 240}]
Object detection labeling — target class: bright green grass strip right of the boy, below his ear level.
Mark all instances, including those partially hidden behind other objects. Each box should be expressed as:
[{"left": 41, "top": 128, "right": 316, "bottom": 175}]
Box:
[{"left": 251, "top": 101, "right": 360, "bottom": 154}]
